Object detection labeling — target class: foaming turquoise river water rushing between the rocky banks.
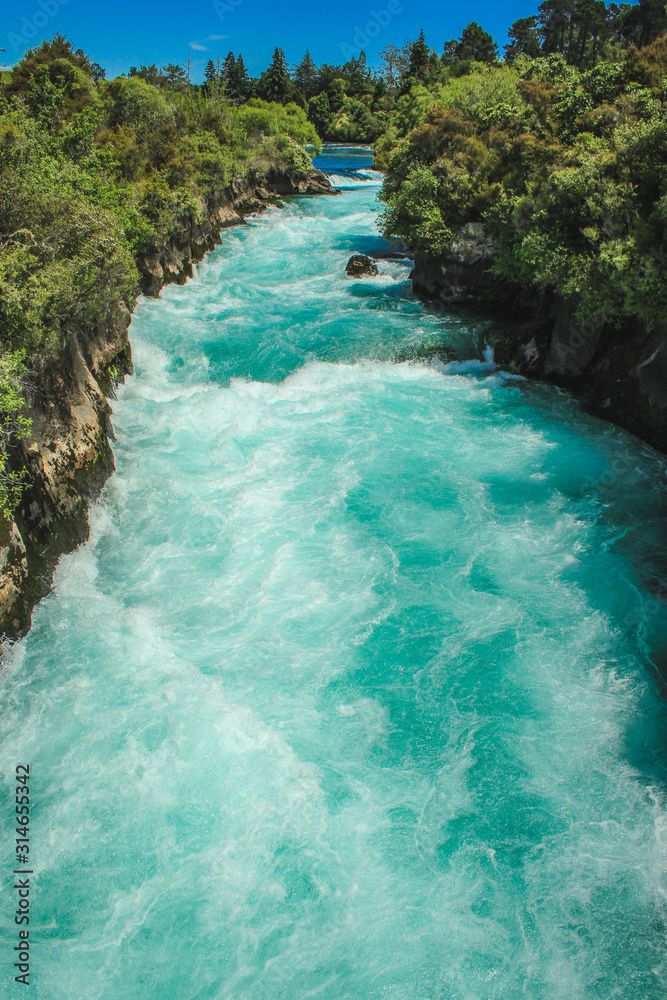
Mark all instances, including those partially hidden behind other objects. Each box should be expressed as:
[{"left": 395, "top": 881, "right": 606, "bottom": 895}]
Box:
[{"left": 0, "top": 153, "right": 667, "bottom": 1000}]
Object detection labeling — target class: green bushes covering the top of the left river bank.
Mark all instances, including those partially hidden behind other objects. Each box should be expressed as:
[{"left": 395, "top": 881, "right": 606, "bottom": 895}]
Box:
[{"left": 0, "top": 36, "right": 319, "bottom": 510}]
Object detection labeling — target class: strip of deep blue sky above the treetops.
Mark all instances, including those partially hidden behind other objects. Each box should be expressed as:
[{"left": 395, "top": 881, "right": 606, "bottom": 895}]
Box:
[{"left": 0, "top": 0, "right": 539, "bottom": 81}]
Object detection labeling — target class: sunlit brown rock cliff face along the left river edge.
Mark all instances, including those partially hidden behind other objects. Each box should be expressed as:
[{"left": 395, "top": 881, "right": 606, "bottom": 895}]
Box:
[{"left": 0, "top": 170, "right": 333, "bottom": 638}]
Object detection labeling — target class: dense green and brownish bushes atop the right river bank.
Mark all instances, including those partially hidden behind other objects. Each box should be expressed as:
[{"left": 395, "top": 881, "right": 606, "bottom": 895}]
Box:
[{"left": 377, "top": 6, "right": 667, "bottom": 325}]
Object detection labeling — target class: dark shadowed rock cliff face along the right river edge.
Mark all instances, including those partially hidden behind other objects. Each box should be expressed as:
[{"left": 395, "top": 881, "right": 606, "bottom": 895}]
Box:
[{"left": 412, "top": 227, "right": 667, "bottom": 452}]
